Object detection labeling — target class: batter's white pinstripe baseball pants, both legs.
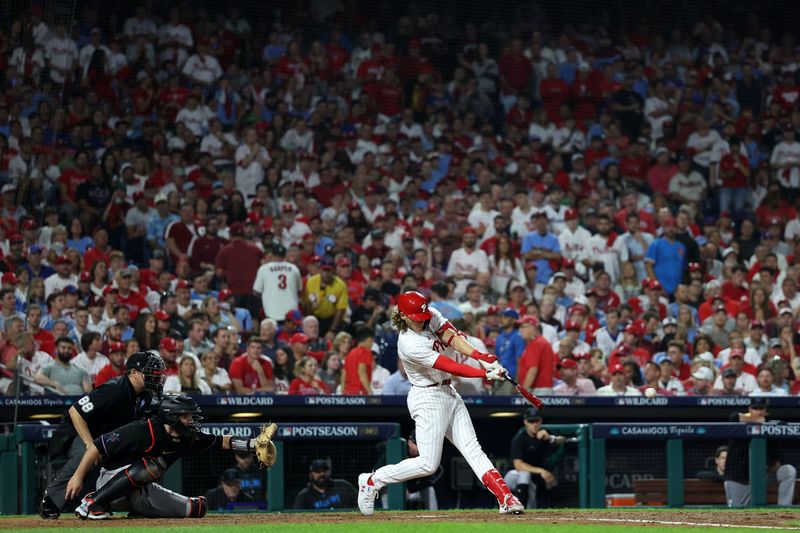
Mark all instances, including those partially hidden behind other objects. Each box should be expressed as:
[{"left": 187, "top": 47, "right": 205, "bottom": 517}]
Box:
[{"left": 372, "top": 385, "right": 494, "bottom": 488}]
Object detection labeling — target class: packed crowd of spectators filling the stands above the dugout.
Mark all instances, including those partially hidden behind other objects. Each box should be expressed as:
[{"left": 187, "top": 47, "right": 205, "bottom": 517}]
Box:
[{"left": 0, "top": 1, "right": 800, "bottom": 396}]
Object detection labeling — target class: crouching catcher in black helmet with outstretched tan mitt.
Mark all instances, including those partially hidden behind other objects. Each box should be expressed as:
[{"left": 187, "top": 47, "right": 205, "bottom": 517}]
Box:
[{"left": 66, "top": 394, "right": 278, "bottom": 520}]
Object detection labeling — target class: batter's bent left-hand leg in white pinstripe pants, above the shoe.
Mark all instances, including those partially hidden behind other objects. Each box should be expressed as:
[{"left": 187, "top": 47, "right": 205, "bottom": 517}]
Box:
[{"left": 372, "top": 387, "right": 450, "bottom": 489}]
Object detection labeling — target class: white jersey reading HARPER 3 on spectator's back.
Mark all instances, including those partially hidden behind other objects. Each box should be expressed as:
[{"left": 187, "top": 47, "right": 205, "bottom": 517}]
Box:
[{"left": 253, "top": 261, "right": 303, "bottom": 320}]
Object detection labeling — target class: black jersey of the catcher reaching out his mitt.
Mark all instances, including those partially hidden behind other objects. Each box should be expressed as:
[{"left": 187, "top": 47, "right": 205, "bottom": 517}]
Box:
[{"left": 94, "top": 417, "right": 222, "bottom": 470}]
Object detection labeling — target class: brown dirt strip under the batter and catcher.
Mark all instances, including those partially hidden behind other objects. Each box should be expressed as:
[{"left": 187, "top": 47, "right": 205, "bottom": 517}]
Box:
[{"left": 0, "top": 509, "right": 800, "bottom": 530}]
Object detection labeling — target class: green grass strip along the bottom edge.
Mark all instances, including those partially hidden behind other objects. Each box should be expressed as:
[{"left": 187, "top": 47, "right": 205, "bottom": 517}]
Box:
[{"left": 7, "top": 521, "right": 800, "bottom": 533}]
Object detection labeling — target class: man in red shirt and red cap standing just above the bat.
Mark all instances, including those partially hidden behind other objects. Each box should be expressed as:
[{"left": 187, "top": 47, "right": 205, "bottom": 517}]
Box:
[{"left": 517, "top": 315, "right": 557, "bottom": 394}]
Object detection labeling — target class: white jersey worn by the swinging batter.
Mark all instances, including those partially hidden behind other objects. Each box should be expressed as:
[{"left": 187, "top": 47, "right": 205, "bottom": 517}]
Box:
[{"left": 397, "top": 306, "right": 453, "bottom": 387}]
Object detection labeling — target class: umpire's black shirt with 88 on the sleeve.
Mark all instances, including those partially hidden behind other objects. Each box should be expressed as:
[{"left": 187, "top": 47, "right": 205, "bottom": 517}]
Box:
[{"left": 50, "top": 375, "right": 150, "bottom": 456}]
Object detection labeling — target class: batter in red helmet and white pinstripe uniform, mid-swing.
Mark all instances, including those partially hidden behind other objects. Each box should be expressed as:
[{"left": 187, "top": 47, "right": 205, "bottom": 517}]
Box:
[{"left": 358, "top": 291, "right": 525, "bottom": 516}]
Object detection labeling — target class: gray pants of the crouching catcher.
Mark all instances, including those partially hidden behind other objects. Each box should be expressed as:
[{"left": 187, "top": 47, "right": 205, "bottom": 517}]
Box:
[{"left": 97, "top": 465, "right": 190, "bottom": 518}]
